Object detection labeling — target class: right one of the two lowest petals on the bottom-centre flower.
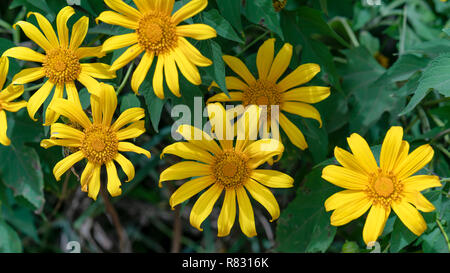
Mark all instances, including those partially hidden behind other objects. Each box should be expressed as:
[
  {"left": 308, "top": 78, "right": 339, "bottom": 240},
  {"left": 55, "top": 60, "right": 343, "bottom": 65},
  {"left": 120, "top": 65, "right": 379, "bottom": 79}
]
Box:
[{"left": 236, "top": 187, "right": 257, "bottom": 237}]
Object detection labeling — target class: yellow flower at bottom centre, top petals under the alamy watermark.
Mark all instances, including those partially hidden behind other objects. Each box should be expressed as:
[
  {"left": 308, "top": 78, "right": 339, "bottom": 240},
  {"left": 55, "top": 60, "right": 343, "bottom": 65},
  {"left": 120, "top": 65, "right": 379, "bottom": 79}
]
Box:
[{"left": 159, "top": 104, "right": 293, "bottom": 237}]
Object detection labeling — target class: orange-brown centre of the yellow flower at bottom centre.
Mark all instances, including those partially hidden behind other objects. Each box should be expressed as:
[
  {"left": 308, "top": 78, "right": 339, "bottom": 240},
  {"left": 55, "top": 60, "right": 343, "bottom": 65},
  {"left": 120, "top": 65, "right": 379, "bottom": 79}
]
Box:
[{"left": 212, "top": 150, "right": 250, "bottom": 188}]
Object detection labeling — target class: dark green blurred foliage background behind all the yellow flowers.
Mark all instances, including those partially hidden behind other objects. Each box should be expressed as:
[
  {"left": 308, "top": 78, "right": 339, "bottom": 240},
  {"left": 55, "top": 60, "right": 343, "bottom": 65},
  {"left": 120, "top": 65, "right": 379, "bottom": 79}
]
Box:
[{"left": 0, "top": 0, "right": 450, "bottom": 253}]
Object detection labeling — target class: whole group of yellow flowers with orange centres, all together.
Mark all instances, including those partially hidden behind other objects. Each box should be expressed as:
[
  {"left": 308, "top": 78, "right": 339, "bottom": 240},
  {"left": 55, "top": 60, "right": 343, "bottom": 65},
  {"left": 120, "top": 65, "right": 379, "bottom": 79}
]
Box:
[{"left": 0, "top": 0, "right": 440, "bottom": 243}]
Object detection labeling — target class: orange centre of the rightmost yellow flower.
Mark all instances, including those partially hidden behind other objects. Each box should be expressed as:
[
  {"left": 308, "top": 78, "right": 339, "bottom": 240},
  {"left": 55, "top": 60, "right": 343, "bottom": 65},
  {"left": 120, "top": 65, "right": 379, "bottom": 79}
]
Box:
[{"left": 367, "top": 169, "right": 403, "bottom": 207}]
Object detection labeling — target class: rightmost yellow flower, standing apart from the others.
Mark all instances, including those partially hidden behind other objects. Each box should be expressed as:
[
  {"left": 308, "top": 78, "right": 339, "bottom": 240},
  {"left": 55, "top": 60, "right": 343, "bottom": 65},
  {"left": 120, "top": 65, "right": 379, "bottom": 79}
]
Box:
[{"left": 322, "top": 126, "right": 441, "bottom": 244}]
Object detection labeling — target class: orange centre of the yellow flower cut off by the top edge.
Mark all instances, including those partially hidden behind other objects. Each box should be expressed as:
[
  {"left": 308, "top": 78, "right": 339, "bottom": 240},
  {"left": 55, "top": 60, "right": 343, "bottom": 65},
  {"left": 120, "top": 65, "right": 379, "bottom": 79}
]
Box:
[{"left": 136, "top": 12, "right": 178, "bottom": 55}]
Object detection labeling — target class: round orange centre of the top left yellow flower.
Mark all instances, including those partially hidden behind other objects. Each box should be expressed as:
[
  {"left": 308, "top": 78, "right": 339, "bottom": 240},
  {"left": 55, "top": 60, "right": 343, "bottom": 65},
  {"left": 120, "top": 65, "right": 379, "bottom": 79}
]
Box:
[{"left": 42, "top": 48, "right": 81, "bottom": 84}]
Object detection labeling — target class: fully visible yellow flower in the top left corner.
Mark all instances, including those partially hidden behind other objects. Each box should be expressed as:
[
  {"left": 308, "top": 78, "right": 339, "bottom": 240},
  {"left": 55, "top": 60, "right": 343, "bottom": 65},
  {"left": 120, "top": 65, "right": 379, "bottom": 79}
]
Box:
[{"left": 3, "top": 6, "right": 115, "bottom": 125}]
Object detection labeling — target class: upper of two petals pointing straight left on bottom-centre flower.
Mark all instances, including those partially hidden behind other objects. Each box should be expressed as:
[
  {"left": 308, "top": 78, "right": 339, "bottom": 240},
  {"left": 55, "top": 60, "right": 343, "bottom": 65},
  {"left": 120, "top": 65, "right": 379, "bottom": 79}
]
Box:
[{"left": 161, "top": 142, "right": 214, "bottom": 164}]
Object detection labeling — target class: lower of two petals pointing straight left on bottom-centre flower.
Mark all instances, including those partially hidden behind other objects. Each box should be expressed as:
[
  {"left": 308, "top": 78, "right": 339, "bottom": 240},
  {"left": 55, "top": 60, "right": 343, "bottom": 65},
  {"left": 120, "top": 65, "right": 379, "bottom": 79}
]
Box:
[{"left": 159, "top": 161, "right": 211, "bottom": 187}]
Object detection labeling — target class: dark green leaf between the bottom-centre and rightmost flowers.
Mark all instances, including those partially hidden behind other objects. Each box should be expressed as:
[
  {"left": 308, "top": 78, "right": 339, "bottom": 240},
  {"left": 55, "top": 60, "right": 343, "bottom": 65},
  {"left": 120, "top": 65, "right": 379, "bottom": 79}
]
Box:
[{"left": 276, "top": 168, "right": 337, "bottom": 252}]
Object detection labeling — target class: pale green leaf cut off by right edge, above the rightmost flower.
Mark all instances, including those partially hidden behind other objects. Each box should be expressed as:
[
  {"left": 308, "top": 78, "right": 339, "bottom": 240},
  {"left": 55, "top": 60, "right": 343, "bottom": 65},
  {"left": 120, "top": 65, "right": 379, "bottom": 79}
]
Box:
[{"left": 400, "top": 54, "right": 450, "bottom": 115}]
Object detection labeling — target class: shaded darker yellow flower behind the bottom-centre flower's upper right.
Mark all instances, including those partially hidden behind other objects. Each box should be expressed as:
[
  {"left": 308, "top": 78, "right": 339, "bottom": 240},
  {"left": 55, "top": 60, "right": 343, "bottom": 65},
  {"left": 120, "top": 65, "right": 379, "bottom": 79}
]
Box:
[{"left": 207, "top": 39, "right": 330, "bottom": 150}]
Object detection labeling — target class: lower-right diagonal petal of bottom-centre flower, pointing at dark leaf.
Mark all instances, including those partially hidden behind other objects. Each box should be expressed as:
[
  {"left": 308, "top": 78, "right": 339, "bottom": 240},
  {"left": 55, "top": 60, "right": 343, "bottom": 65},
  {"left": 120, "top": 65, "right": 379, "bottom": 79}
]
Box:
[{"left": 244, "top": 179, "right": 280, "bottom": 222}]
